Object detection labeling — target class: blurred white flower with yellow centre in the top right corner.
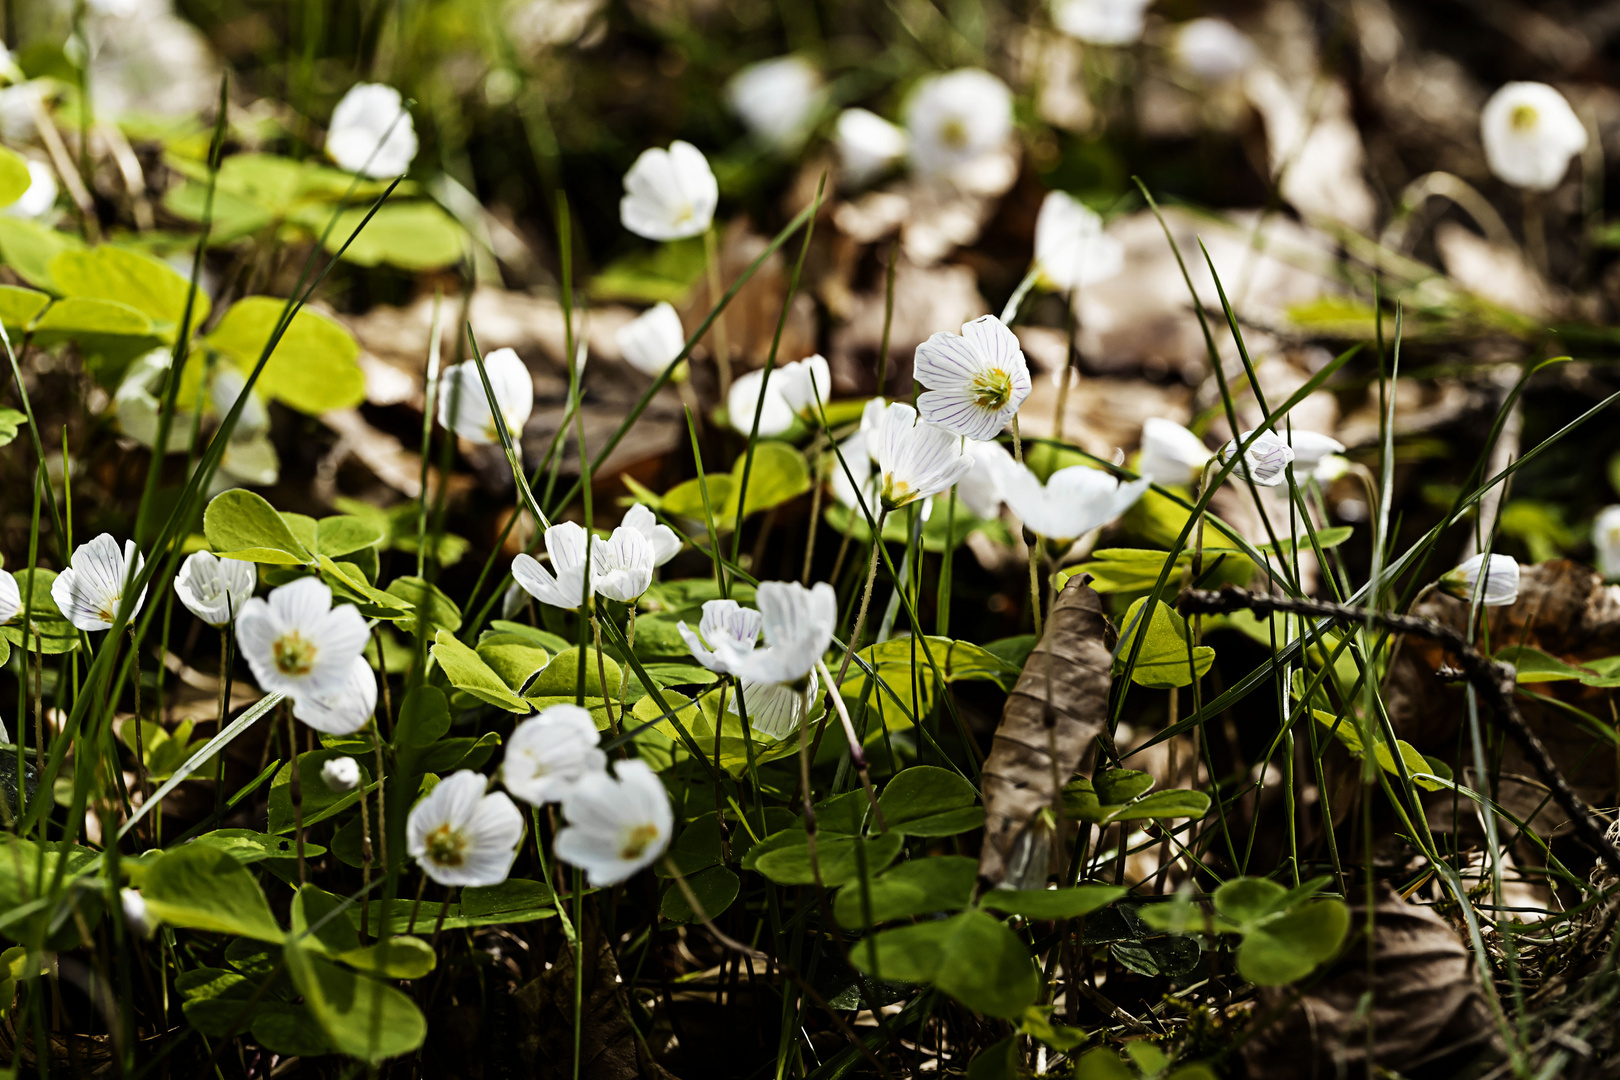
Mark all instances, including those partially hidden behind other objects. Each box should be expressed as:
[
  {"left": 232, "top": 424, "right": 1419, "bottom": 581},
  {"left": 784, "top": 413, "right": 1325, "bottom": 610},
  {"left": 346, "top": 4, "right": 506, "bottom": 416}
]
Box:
[{"left": 1479, "top": 83, "right": 1586, "bottom": 191}]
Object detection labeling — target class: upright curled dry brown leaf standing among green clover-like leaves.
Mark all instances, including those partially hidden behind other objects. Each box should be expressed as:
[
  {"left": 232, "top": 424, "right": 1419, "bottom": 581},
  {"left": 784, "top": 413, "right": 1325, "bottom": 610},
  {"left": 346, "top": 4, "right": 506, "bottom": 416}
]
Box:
[{"left": 978, "top": 575, "right": 1113, "bottom": 884}]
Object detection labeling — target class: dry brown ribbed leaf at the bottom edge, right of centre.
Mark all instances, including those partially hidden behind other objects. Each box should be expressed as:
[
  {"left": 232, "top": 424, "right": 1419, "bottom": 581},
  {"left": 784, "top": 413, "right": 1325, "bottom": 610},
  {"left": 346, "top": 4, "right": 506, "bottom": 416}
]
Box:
[{"left": 1243, "top": 884, "right": 1495, "bottom": 1080}]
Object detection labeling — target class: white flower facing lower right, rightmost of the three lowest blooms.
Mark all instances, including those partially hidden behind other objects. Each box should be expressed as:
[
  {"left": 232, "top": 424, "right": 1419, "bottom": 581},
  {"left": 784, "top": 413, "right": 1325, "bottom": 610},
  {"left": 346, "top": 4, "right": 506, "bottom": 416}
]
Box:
[{"left": 556, "top": 759, "right": 676, "bottom": 889}]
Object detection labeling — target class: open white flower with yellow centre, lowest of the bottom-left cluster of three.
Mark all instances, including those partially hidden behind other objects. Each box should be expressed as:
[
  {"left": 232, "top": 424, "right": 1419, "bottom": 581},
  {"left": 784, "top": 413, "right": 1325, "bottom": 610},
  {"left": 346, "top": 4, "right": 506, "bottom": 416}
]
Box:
[{"left": 405, "top": 769, "right": 523, "bottom": 887}]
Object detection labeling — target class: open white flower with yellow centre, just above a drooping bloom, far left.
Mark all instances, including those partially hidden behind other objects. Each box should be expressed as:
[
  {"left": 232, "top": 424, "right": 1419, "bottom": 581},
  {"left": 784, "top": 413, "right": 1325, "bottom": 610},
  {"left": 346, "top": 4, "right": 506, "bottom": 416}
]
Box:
[{"left": 237, "top": 578, "right": 368, "bottom": 703}]
